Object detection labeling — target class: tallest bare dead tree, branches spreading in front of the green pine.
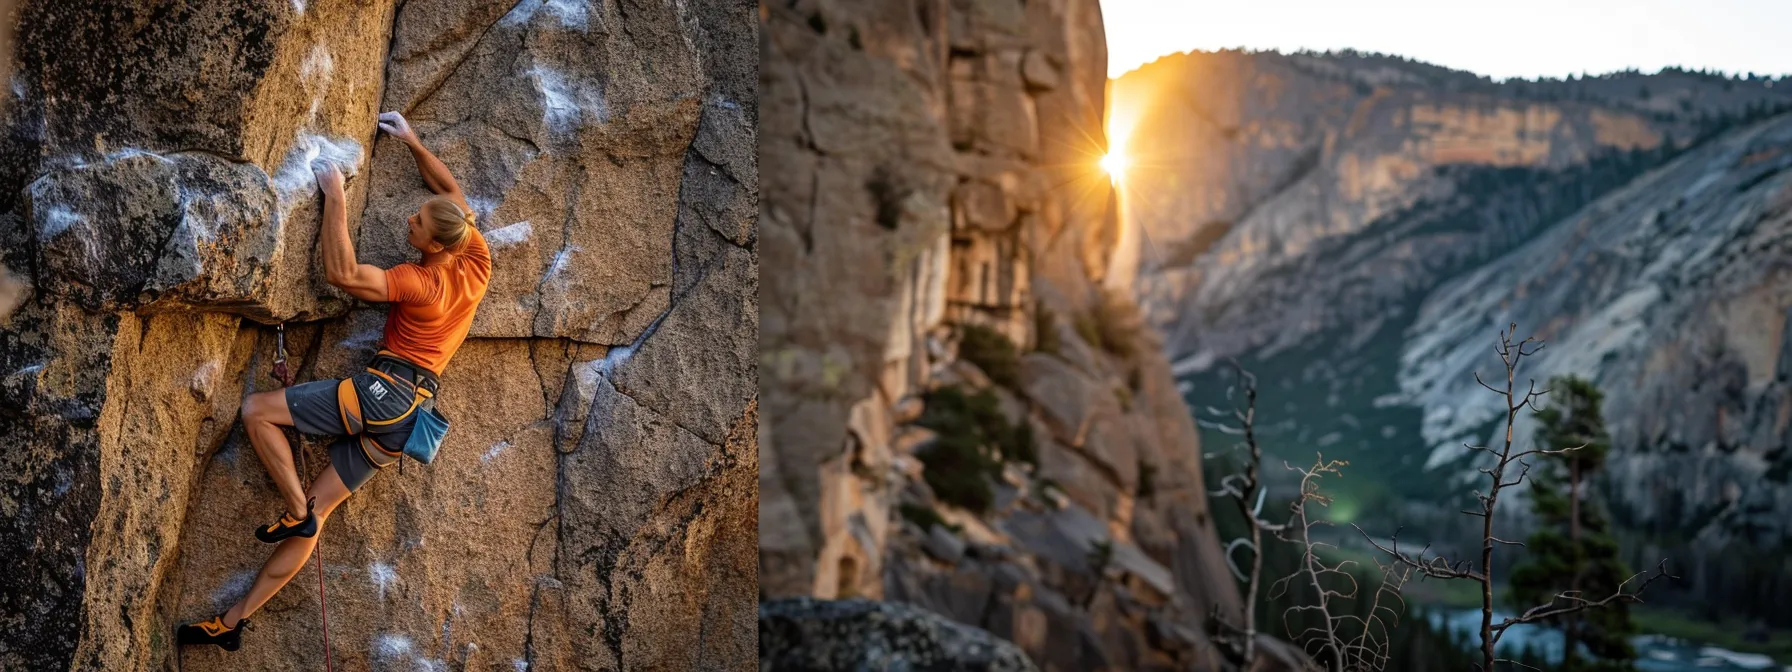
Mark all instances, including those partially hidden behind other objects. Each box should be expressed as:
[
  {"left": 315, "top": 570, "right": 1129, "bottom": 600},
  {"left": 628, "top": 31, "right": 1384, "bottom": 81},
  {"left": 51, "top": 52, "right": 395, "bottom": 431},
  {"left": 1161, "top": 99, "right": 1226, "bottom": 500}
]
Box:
[{"left": 1351, "top": 323, "right": 1668, "bottom": 672}]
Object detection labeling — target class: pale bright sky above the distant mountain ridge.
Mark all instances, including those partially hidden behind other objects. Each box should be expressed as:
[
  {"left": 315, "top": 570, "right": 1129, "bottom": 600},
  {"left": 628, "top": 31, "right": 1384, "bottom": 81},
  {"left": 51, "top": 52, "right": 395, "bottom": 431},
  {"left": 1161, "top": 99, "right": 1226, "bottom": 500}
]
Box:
[{"left": 1100, "top": 0, "right": 1792, "bottom": 79}]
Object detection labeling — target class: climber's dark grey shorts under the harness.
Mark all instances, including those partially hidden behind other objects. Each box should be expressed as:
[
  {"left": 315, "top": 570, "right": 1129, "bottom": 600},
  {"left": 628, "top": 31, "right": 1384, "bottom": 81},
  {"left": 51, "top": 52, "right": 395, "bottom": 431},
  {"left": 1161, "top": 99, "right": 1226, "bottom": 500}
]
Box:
[{"left": 287, "top": 371, "right": 418, "bottom": 493}]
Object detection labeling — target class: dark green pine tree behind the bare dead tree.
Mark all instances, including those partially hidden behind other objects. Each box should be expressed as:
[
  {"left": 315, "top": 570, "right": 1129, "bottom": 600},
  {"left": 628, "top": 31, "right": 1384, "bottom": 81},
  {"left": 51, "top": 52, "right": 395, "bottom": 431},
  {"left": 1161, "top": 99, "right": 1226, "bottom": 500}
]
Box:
[{"left": 1511, "top": 376, "right": 1636, "bottom": 672}]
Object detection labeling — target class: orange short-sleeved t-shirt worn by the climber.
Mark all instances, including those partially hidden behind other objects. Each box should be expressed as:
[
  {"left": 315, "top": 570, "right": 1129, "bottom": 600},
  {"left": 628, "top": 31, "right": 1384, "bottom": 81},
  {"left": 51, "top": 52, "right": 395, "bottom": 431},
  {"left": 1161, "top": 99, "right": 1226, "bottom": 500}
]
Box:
[{"left": 385, "top": 228, "right": 491, "bottom": 375}]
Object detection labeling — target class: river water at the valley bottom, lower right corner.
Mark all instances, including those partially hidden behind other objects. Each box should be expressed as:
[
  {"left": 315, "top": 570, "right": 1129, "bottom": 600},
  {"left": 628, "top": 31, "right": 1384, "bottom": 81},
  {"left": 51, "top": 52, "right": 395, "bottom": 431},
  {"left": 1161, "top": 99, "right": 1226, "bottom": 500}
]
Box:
[{"left": 1428, "top": 609, "right": 1792, "bottom": 672}]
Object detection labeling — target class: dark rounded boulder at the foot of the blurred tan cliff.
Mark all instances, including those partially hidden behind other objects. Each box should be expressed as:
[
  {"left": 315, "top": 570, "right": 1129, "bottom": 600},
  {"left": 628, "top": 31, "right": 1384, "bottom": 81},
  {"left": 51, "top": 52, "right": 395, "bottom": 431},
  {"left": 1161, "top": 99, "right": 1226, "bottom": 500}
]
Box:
[{"left": 760, "top": 597, "right": 1038, "bottom": 672}]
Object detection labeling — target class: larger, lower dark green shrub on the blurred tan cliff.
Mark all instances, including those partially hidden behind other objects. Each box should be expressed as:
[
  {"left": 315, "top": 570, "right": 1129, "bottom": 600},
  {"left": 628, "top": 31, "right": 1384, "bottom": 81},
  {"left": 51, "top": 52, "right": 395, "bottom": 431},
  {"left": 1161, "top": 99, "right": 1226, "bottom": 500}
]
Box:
[{"left": 916, "top": 385, "right": 1038, "bottom": 513}]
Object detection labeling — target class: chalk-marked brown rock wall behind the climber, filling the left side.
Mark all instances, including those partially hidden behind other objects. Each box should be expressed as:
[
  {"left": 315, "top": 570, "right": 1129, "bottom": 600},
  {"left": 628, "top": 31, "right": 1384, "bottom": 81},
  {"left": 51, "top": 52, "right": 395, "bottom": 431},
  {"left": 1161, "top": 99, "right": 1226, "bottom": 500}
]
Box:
[{"left": 0, "top": 0, "right": 758, "bottom": 670}]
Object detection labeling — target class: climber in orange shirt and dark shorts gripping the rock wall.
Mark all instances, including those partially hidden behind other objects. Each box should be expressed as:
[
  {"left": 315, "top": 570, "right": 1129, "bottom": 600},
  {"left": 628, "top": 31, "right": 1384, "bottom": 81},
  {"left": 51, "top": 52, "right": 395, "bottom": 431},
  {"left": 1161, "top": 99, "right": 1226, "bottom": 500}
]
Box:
[{"left": 177, "top": 111, "right": 491, "bottom": 650}]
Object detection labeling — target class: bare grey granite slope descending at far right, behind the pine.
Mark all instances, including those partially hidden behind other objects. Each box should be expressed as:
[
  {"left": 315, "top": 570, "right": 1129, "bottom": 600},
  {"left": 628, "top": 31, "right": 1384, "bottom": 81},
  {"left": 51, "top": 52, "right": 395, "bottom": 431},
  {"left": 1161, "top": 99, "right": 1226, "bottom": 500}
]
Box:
[{"left": 1400, "top": 116, "right": 1792, "bottom": 559}]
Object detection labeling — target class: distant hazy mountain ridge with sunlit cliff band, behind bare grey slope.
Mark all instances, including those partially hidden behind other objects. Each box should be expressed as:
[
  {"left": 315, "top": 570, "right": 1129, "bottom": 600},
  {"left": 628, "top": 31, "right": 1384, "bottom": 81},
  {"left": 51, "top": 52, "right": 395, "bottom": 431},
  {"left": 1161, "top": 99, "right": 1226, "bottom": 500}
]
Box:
[{"left": 1115, "top": 52, "right": 1792, "bottom": 366}]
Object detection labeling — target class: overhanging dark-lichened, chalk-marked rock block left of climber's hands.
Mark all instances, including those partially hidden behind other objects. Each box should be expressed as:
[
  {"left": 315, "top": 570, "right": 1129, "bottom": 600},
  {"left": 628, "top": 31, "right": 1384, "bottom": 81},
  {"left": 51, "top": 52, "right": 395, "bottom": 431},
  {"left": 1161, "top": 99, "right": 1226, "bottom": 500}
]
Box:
[{"left": 4, "top": 0, "right": 392, "bottom": 321}]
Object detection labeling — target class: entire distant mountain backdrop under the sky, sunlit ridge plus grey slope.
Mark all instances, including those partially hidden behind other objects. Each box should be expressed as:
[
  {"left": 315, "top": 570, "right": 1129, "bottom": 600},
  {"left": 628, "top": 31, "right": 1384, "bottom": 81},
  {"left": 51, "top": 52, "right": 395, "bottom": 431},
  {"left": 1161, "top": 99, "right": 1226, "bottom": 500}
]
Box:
[{"left": 1113, "top": 52, "right": 1792, "bottom": 620}]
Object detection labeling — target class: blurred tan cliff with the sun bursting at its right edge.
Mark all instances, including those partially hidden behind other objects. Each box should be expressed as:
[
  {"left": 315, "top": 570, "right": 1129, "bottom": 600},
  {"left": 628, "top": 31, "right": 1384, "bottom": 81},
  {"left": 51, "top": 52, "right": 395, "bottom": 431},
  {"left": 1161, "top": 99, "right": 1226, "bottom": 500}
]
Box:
[{"left": 760, "top": 0, "right": 1238, "bottom": 670}]
